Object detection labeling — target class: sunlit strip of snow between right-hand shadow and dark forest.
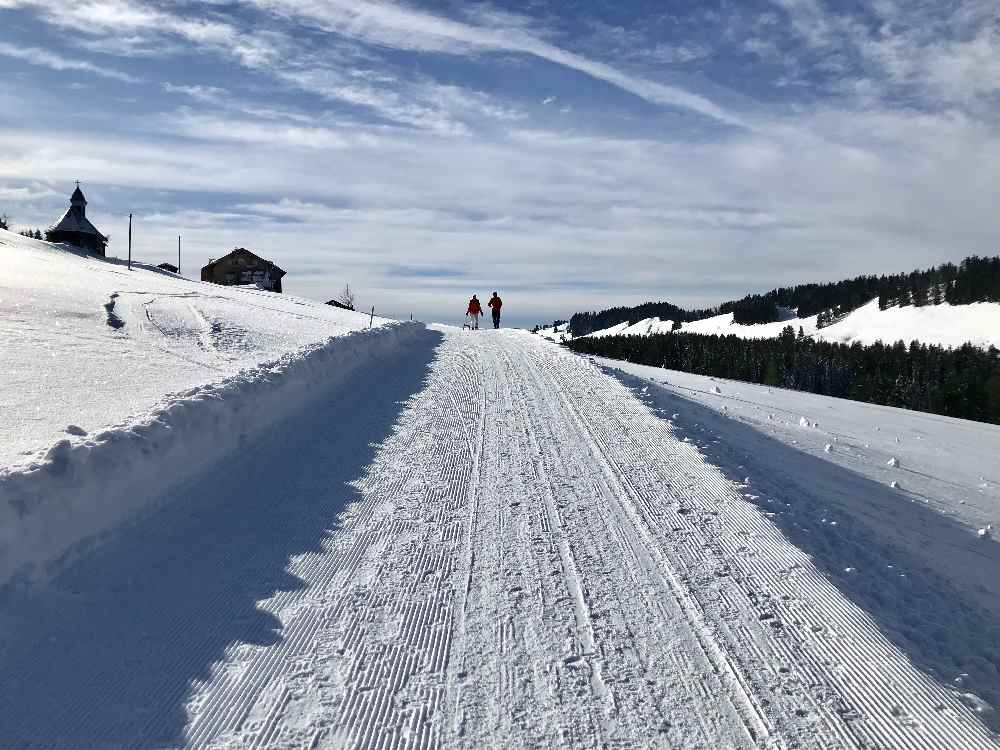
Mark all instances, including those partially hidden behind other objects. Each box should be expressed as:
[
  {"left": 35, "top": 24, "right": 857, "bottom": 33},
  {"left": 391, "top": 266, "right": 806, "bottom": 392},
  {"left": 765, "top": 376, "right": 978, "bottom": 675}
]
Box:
[{"left": 592, "top": 357, "right": 1000, "bottom": 536}]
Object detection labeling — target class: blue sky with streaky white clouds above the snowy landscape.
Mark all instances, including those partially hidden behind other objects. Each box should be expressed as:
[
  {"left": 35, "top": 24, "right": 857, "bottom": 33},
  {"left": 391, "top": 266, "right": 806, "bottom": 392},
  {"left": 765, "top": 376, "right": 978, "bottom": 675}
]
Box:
[{"left": 0, "top": 0, "right": 1000, "bottom": 325}]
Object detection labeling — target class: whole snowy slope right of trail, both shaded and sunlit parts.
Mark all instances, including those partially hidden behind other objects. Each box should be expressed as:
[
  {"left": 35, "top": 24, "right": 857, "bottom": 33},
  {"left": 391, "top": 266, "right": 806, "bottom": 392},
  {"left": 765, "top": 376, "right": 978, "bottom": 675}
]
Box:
[{"left": 591, "top": 357, "right": 1000, "bottom": 727}]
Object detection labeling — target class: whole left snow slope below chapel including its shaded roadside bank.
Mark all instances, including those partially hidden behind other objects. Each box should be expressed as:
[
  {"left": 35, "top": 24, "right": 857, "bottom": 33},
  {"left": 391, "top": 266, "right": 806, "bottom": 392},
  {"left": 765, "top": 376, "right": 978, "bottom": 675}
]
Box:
[{"left": 0, "top": 232, "right": 422, "bottom": 586}]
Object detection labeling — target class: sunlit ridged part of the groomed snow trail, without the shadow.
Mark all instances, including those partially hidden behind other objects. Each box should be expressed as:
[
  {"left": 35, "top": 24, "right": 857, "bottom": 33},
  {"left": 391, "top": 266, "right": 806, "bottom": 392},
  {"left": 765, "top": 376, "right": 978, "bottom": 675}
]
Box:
[{"left": 0, "top": 329, "right": 998, "bottom": 750}]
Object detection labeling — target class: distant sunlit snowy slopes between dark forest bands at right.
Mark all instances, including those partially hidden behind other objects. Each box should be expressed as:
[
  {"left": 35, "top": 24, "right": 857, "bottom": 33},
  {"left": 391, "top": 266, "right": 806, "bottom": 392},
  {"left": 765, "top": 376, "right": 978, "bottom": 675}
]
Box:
[{"left": 589, "top": 299, "right": 1000, "bottom": 348}]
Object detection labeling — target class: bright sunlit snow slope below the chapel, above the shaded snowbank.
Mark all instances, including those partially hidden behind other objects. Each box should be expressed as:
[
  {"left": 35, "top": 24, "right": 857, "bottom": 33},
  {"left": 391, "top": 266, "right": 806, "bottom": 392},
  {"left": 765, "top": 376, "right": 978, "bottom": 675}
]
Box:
[{"left": 0, "top": 230, "right": 386, "bottom": 468}]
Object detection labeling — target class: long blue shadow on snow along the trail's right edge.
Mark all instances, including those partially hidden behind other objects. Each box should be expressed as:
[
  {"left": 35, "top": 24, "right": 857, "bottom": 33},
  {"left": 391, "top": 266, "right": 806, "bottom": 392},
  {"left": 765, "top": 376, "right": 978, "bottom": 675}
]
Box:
[{"left": 604, "top": 368, "right": 1000, "bottom": 731}]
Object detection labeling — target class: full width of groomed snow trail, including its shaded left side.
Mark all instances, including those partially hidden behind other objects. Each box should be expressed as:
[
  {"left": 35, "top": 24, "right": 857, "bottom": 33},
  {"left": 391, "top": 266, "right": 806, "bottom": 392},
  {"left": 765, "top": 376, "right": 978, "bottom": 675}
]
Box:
[{"left": 0, "top": 329, "right": 998, "bottom": 750}]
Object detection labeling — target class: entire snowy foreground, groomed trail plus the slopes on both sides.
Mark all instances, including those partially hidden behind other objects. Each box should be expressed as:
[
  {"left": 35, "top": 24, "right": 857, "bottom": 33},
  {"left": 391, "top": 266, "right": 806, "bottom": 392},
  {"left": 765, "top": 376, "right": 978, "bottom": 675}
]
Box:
[{"left": 0, "top": 233, "right": 1000, "bottom": 750}]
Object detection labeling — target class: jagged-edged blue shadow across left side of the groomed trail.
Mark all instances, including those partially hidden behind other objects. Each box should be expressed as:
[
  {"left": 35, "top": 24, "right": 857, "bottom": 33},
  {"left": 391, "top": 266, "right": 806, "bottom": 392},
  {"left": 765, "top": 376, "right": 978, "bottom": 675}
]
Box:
[{"left": 0, "top": 331, "right": 441, "bottom": 749}]
